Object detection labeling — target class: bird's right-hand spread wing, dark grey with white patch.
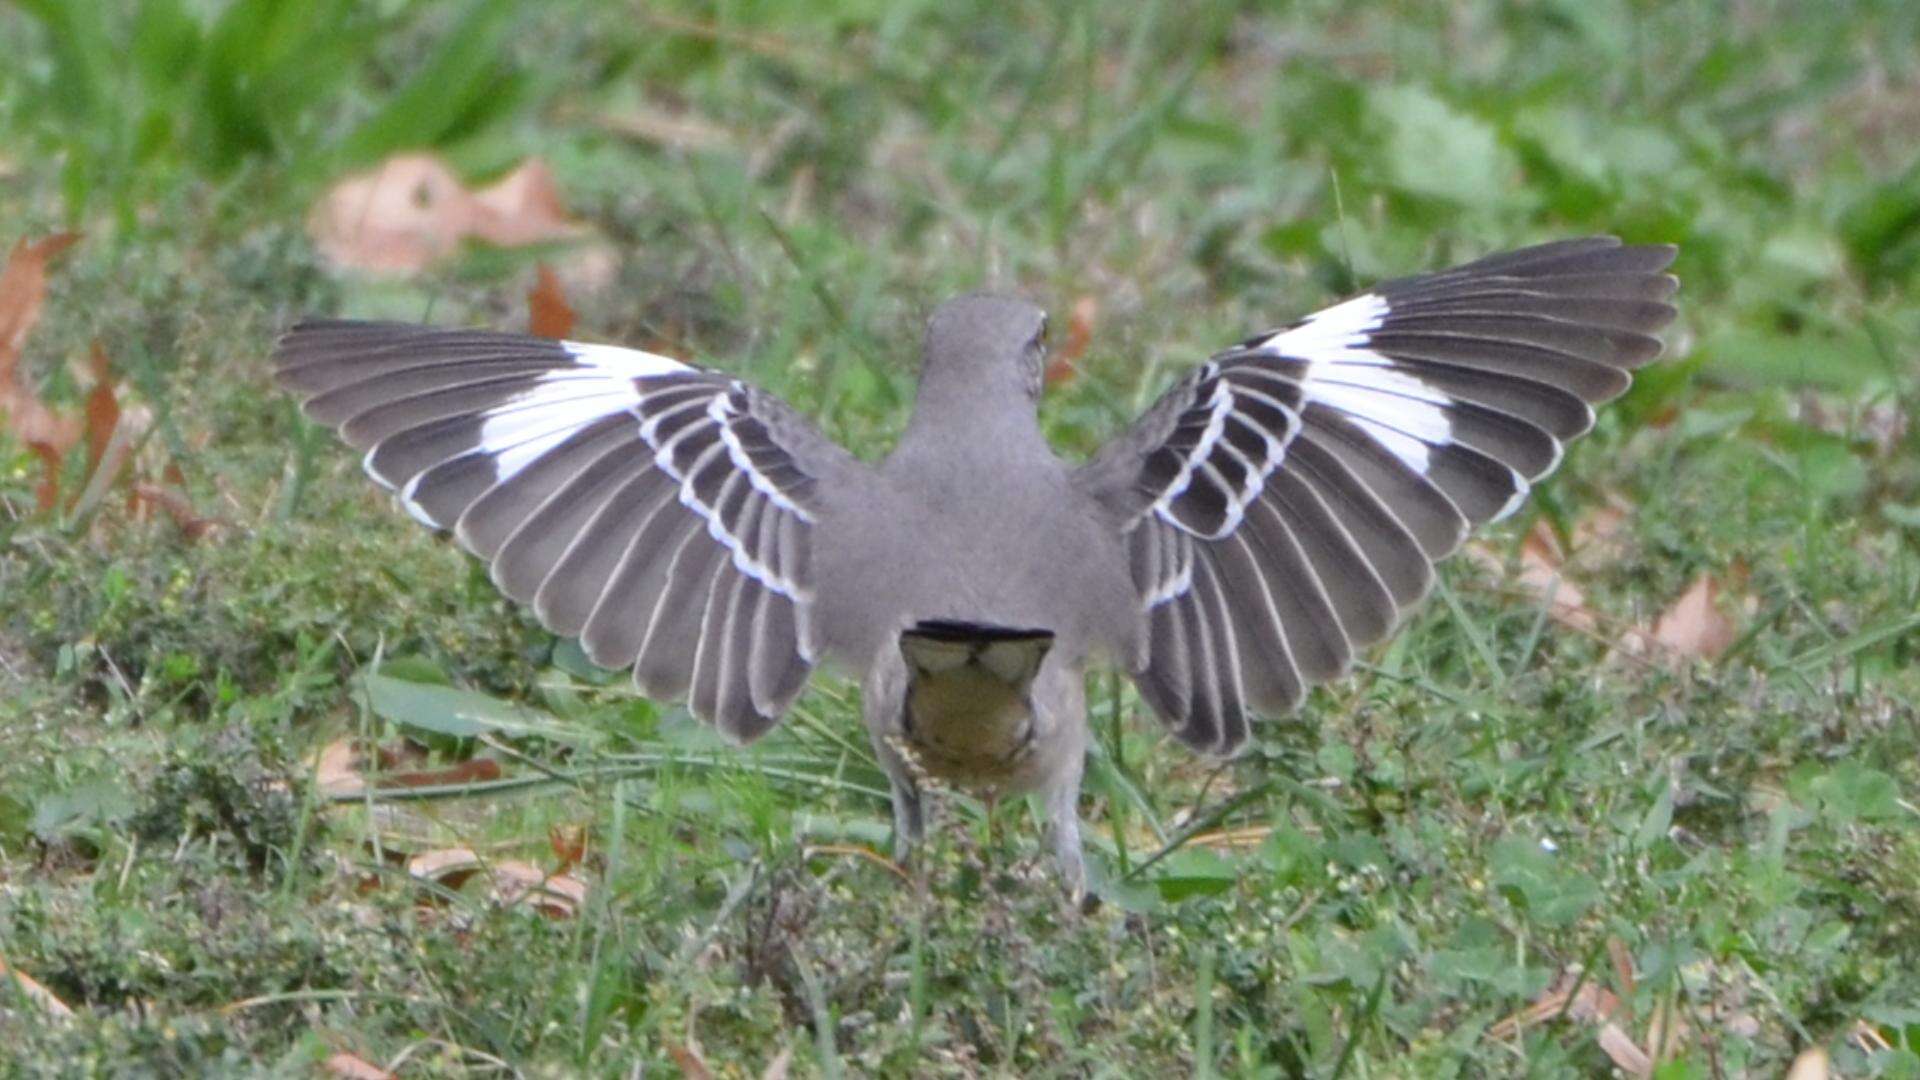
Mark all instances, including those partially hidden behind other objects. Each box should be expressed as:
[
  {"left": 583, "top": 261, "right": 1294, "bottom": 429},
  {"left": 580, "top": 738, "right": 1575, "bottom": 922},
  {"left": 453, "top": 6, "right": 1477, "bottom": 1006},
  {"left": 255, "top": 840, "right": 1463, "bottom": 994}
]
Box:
[{"left": 1075, "top": 236, "right": 1676, "bottom": 753}]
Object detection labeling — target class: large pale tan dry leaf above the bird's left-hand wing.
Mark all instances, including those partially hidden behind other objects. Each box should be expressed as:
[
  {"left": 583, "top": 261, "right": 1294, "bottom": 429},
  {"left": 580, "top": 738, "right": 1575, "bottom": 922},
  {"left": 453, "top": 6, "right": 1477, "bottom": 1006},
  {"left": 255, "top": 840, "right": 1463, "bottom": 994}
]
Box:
[{"left": 307, "top": 154, "right": 584, "bottom": 273}]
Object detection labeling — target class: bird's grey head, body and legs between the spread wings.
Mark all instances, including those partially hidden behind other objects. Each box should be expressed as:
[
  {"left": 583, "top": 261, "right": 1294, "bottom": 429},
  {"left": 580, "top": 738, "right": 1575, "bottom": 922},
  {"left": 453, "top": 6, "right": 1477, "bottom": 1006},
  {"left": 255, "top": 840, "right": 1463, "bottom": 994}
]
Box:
[{"left": 814, "top": 296, "right": 1139, "bottom": 884}]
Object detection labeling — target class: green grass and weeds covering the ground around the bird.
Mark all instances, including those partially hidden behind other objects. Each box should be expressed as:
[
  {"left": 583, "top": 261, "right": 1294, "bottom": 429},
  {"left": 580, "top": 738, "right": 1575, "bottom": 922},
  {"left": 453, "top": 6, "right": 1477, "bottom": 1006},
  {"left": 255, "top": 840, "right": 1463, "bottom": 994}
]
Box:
[{"left": 0, "top": 0, "right": 1920, "bottom": 1078}]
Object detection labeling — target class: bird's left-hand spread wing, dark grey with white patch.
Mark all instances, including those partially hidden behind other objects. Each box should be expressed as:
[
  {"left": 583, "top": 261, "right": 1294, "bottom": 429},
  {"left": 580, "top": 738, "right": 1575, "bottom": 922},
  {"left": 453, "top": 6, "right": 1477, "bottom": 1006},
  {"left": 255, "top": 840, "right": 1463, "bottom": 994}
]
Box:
[{"left": 275, "top": 321, "right": 860, "bottom": 742}]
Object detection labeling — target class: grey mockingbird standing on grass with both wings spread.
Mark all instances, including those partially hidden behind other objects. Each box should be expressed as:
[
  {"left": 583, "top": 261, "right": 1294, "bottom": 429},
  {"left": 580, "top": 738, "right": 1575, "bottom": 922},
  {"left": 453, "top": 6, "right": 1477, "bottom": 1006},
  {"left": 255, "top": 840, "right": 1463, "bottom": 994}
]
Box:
[{"left": 276, "top": 236, "right": 1676, "bottom": 890}]
